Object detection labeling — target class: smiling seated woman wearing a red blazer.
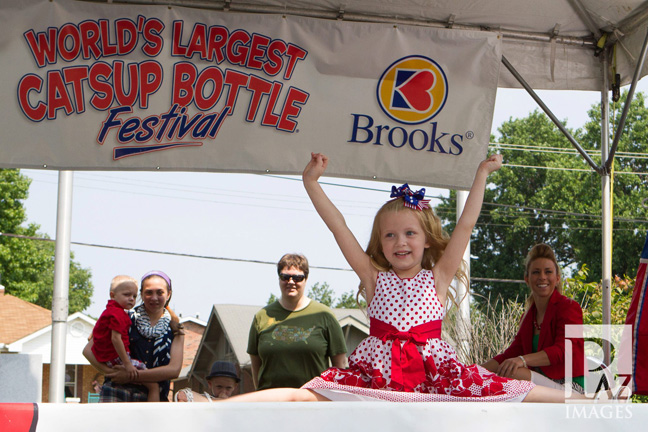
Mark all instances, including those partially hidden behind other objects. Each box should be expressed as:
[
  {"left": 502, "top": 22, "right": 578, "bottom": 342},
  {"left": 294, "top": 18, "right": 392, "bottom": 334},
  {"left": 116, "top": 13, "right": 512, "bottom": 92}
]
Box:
[{"left": 483, "top": 244, "right": 584, "bottom": 393}]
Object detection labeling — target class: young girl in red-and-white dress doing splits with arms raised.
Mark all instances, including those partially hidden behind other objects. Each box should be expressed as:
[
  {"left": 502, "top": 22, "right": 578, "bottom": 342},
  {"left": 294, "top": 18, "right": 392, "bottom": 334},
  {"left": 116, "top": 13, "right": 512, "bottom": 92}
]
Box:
[{"left": 230, "top": 153, "right": 564, "bottom": 402}]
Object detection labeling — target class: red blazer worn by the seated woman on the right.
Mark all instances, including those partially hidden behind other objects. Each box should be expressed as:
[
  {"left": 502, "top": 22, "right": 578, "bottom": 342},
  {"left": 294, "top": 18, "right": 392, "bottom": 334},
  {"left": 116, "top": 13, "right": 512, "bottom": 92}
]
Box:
[{"left": 495, "top": 291, "right": 585, "bottom": 380}]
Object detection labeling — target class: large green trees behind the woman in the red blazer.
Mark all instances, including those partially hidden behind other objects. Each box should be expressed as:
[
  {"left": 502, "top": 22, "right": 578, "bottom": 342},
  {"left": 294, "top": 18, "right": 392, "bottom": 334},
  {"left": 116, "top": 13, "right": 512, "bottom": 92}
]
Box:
[{"left": 438, "top": 93, "right": 648, "bottom": 301}]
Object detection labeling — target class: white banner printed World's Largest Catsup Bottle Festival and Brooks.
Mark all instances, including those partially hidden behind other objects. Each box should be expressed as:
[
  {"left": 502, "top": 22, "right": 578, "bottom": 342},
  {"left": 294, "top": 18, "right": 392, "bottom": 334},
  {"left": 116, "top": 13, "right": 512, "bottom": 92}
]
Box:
[{"left": 0, "top": 0, "right": 501, "bottom": 189}]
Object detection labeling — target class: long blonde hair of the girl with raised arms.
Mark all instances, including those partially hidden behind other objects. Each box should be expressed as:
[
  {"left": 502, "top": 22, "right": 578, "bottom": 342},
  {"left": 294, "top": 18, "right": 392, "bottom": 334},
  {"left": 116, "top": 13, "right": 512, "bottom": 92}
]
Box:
[{"left": 357, "top": 198, "right": 468, "bottom": 305}]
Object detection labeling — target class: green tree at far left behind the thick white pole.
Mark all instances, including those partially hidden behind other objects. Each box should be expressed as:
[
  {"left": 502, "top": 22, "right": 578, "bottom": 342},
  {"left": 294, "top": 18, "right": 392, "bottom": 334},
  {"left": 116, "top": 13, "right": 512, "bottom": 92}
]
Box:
[{"left": 0, "top": 169, "right": 94, "bottom": 313}]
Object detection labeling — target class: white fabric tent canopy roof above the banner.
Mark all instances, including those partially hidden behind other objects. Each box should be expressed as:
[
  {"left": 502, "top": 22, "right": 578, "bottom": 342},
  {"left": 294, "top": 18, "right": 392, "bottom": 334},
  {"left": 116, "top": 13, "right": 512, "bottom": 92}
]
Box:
[{"left": 114, "top": 0, "right": 648, "bottom": 91}]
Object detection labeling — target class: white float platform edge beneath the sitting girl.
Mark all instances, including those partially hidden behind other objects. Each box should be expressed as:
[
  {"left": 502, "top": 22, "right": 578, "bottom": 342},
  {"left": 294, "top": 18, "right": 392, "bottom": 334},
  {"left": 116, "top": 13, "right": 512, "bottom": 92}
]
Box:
[{"left": 0, "top": 402, "right": 648, "bottom": 432}]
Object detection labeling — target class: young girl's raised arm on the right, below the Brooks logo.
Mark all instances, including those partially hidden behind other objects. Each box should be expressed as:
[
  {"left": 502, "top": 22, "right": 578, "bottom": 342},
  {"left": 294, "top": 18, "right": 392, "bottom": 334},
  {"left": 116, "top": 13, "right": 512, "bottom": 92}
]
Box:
[{"left": 434, "top": 155, "right": 502, "bottom": 302}]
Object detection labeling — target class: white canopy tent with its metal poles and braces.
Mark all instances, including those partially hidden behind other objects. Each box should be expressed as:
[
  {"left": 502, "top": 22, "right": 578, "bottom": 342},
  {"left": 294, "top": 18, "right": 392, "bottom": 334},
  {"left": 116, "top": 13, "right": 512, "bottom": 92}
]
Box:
[{"left": 11, "top": 0, "right": 648, "bottom": 401}]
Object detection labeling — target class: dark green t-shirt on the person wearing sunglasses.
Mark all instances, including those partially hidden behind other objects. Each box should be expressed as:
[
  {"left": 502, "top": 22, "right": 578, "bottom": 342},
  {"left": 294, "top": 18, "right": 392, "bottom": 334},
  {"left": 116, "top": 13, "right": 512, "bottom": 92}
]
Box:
[{"left": 247, "top": 300, "right": 346, "bottom": 390}]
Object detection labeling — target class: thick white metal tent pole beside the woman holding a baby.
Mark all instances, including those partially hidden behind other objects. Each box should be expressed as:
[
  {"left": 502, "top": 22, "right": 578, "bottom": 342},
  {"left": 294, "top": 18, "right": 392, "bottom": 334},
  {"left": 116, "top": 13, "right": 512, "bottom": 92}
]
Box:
[{"left": 49, "top": 171, "right": 73, "bottom": 403}]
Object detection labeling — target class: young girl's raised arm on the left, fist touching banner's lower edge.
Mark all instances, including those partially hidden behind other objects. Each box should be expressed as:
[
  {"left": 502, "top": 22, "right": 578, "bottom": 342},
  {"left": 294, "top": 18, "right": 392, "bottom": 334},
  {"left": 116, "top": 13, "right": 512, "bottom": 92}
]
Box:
[{"left": 302, "top": 153, "right": 377, "bottom": 303}]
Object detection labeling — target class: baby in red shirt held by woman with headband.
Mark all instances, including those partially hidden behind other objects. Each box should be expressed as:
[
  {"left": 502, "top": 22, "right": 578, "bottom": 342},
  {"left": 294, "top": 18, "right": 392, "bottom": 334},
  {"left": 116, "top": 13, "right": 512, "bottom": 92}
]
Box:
[{"left": 92, "top": 275, "right": 160, "bottom": 402}]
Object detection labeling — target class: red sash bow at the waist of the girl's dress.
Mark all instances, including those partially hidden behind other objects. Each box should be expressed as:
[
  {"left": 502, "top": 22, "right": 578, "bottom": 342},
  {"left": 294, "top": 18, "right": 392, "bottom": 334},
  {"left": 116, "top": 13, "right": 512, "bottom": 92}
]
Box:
[{"left": 369, "top": 318, "right": 442, "bottom": 392}]
